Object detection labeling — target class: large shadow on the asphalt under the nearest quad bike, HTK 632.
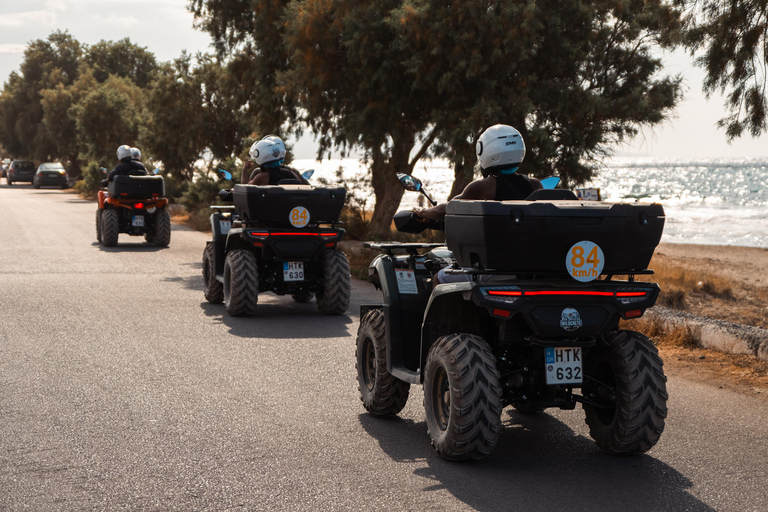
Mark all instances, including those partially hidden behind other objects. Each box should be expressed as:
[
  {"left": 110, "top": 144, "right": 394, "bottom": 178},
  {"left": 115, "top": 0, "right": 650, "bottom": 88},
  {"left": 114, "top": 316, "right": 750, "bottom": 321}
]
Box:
[{"left": 360, "top": 410, "right": 714, "bottom": 511}]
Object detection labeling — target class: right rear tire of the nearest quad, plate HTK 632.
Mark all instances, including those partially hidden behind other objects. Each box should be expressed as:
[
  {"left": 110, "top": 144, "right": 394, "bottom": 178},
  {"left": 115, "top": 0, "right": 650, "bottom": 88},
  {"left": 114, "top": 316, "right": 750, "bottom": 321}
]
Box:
[{"left": 582, "top": 331, "right": 668, "bottom": 455}]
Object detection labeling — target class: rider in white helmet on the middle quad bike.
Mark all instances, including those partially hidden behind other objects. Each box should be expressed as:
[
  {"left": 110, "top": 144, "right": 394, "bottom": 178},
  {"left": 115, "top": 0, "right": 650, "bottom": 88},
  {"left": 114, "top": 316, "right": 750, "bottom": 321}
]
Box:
[{"left": 240, "top": 135, "right": 309, "bottom": 185}]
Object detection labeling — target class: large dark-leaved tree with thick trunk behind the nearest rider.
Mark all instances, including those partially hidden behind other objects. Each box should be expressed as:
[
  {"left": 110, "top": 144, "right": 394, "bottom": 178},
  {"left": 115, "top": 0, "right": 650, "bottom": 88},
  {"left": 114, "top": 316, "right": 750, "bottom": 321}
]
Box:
[{"left": 192, "top": 0, "right": 680, "bottom": 235}]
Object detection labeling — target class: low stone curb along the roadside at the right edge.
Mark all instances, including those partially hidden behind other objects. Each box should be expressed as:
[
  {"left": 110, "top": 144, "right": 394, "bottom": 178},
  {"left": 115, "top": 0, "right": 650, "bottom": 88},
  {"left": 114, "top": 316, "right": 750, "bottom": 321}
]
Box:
[{"left": 647, "top": 306, "right": 768, "bottom": 361}]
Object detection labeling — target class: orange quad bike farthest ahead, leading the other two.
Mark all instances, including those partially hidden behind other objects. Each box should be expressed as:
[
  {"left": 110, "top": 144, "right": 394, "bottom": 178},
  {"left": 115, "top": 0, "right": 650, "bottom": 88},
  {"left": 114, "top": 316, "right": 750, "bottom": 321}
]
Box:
[{"left": 96, "top": 168, "right": 171, "bottom": 247}]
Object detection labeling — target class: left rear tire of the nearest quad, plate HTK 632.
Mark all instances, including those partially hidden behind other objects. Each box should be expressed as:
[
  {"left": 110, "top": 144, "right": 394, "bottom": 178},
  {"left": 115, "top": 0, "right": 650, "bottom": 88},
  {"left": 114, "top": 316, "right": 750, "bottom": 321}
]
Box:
[{"left": 424, "top": 333, "right": 502, "bottom": 460}]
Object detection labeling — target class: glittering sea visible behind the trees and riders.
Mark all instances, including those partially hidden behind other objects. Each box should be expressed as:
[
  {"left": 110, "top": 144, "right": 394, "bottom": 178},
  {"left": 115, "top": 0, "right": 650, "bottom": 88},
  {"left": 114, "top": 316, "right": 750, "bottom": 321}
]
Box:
[{"left": 292, "top": 157, "right": 768, "bottom": 248}]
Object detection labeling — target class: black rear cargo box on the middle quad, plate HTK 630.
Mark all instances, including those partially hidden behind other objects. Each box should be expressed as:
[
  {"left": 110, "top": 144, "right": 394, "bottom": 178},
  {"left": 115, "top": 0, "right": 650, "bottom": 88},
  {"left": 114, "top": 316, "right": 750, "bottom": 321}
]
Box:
[{"left": 233, "top": 185, "right": 346, "bottom": 227}]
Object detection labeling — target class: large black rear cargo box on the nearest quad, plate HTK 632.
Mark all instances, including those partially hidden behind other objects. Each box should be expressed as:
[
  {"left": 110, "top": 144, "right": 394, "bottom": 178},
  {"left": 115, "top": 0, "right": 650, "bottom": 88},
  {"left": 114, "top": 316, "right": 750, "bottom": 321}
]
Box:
[{"left": 445, "top": 201, "right": 664, "bottom": 274}]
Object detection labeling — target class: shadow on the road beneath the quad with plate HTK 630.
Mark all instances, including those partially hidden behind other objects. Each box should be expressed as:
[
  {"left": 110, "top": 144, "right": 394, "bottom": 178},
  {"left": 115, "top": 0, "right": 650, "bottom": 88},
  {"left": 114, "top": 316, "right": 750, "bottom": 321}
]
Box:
[{"left": 200, "top": 300, "right": 352, "bottom": 339}]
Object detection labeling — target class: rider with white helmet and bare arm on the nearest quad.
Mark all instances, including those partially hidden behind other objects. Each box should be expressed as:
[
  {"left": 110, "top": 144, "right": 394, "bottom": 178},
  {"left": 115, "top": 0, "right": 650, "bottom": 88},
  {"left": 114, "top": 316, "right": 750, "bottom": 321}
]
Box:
[{"left": 413, "top": 124, "right": 543, "bottom": 285}]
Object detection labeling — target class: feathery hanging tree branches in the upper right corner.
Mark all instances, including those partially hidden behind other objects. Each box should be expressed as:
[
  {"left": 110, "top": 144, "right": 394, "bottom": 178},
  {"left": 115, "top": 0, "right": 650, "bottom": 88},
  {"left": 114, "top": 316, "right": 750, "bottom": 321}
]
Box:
[{"left": 675, "top": 0, "right": 768, "bottom": 141}]
